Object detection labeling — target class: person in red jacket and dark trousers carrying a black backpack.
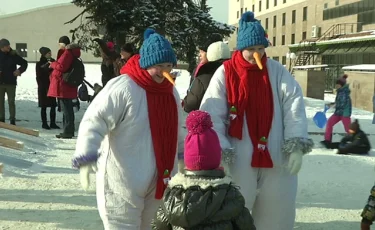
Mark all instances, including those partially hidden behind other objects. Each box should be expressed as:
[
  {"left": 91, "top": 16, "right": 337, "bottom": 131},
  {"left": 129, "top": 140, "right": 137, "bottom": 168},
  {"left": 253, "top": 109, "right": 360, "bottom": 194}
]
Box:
[{"left": 48, "top": 44, "right": 81, "bottom": 139}]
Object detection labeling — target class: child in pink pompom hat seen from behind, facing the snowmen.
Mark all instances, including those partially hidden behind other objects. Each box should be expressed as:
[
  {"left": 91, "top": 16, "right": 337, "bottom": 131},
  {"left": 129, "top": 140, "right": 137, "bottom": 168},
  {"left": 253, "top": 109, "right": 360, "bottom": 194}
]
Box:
[{"left": 153, "top": 110, "right": 255, "bottom": 230}]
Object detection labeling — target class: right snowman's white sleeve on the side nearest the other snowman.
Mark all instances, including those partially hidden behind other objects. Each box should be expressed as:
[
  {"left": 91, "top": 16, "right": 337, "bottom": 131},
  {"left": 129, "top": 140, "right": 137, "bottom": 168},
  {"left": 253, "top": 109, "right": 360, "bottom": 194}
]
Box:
[{"left": 200, "top": 65, "right": 232, "bottom": 151}]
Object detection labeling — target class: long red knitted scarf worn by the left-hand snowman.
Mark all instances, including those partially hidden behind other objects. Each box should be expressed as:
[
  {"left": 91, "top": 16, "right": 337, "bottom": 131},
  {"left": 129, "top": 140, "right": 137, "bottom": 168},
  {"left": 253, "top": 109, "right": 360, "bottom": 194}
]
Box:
[{"left": 121, "top": 55, "right": 178, "bottom": 199}]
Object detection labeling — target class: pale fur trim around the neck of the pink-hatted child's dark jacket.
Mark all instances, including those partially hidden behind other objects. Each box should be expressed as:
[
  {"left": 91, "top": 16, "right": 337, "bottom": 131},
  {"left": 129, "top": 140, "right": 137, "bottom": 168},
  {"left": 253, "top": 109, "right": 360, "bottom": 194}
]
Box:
[{"left": 168, "top": 171, "right": 232, "bottom": 189}]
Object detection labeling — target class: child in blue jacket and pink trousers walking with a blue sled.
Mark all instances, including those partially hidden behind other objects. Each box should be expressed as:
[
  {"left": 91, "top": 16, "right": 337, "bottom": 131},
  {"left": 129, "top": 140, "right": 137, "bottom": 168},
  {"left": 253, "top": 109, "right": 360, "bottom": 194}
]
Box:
[{"left": 321, "top": 74, "right": 352, "bottom": 147}]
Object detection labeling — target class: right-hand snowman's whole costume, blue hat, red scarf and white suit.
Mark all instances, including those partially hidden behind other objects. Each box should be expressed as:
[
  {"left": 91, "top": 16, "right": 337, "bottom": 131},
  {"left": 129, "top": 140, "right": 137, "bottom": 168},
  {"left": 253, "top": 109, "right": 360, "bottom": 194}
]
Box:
[{"left": 200, "top": 12, "right": 313, "bottom": 230}]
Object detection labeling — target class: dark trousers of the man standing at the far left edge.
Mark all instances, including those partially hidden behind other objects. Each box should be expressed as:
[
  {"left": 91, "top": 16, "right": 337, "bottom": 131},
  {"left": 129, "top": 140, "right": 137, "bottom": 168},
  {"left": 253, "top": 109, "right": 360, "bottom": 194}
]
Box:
[{"left": 0, "top": 85, "right": 16, "bottom": 121}]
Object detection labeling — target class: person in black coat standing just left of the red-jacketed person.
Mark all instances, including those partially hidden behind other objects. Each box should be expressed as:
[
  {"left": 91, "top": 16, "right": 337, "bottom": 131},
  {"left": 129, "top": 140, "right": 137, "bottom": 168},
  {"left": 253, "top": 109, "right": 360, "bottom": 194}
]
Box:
[{"left": 35, "top": 47, "right": 60, "bottom": 129}]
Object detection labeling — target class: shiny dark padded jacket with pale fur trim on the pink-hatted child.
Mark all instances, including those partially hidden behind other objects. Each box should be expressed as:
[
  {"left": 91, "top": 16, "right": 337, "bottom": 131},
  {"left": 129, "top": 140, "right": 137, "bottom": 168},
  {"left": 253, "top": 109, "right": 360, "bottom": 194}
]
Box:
[{"left": 152, "top": 170, "right": 255, "bottom": 230}]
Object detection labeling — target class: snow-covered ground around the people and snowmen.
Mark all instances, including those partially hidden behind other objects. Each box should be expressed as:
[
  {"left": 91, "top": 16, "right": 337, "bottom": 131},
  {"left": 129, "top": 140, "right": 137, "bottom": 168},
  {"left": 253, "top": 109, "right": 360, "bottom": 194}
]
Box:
[{"left": 0, "top": 64, "right": 375, "bottom": 230}]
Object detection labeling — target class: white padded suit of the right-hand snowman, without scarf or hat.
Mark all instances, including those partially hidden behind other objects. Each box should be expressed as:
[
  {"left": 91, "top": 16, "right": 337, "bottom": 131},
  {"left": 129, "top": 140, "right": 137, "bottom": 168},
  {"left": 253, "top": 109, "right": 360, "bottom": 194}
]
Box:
[{"left": 200, "top": 59, "right": 312, "bottom": 230}]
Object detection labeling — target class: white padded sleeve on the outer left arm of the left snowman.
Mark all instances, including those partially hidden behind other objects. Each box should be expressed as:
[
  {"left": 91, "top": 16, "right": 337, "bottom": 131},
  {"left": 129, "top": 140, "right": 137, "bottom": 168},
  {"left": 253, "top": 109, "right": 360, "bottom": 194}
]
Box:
[{"left": 72, "top": 77, "right": 126, "bottom": 168}]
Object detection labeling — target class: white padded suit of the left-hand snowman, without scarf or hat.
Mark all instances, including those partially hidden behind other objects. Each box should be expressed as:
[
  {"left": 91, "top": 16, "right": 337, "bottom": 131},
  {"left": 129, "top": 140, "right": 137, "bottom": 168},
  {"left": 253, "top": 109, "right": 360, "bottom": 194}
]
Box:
[{"left": 75, "top": 75, "right": 184, "bottom": 230}]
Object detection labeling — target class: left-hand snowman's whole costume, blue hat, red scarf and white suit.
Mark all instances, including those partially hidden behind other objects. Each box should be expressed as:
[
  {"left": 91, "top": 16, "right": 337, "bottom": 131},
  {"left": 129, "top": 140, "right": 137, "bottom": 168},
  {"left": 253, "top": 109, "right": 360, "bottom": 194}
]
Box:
[{"left": 73, "top": 30, "right": 184, "bottom": 230}]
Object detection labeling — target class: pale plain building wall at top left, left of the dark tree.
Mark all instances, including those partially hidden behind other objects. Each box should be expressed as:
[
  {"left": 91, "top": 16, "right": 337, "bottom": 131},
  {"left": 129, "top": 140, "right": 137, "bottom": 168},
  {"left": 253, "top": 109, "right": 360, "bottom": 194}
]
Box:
[{"left": 0, "top": 4, "right": 101, "bottom": 62}]
